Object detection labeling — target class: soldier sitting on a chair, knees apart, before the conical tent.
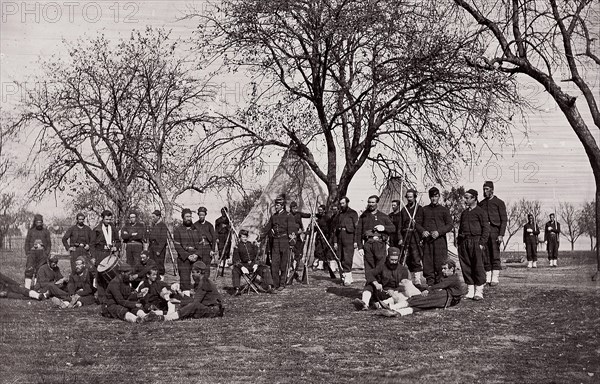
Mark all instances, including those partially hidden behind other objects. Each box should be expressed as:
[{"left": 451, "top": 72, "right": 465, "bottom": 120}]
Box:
[{"left": 231, "top": 229, "right": 275, "bottom": 296}]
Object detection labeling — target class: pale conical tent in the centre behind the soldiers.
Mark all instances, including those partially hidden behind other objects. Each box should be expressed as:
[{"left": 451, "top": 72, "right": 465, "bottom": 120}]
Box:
[{"left": 239, "top": 147, "right": 327, "bottom": 240}]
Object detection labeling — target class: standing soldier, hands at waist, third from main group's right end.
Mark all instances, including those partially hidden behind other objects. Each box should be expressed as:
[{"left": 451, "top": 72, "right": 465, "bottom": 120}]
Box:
[{"left": 416, "top": 187, "right": 453, "bottom": 286}]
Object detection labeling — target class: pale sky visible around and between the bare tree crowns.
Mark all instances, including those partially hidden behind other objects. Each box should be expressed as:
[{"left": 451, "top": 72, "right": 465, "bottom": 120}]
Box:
[{"left": 0, "top": 0, "right": 600, "bottom": 250}]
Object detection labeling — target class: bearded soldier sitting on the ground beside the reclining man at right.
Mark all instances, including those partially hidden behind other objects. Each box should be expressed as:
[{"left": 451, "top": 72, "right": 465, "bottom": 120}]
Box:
[{"left": 352, "top": 247, "right": 420, "bottom": 310}]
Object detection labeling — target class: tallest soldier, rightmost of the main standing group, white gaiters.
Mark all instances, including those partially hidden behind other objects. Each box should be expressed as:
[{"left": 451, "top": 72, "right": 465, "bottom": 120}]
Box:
[{"left": 479, "top": 181, "right": 508, "bottom": 286}]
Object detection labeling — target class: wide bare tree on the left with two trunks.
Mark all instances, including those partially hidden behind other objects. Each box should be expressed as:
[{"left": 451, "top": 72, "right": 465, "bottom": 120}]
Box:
[{"left": 12, "top": 28, "right": 227, "bottom": 222}]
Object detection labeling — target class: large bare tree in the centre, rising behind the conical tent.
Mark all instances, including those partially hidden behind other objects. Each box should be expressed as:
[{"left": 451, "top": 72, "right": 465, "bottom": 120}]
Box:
[{"left": 189, "top": 0, "right": 516, "bottom": 206}]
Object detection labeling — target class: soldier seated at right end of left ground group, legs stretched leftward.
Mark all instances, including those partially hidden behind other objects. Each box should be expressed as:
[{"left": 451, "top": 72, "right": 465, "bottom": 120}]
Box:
[{"left": 148, "top": 261, "right": 224, "bottom": 321}]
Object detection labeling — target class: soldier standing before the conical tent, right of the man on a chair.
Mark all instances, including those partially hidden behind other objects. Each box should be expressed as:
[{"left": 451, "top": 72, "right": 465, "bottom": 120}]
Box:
[{"left": 259, "top": 196, "right": 296, "bottom": 290}]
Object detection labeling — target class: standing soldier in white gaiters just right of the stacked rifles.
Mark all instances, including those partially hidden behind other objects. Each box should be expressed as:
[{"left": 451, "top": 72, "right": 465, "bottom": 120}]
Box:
[{"left": 332, "top": 196, "right": 358, "bottom": 285}]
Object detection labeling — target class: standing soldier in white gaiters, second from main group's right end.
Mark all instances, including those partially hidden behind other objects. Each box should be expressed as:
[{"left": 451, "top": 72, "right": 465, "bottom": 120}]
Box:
[{"left": 457, "top": 189, "right": 490, "bottom": 300}]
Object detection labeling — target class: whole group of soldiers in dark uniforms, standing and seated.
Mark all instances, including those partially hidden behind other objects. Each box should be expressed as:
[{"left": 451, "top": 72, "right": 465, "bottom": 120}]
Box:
[{"left": 0, "top": 181, "right": 560, "bottom": 322}]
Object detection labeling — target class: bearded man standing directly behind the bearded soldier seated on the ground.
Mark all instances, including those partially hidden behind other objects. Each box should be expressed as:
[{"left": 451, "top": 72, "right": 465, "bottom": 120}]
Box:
[{"left": 355, "top": 195, "right": 396, "bottom": 284}]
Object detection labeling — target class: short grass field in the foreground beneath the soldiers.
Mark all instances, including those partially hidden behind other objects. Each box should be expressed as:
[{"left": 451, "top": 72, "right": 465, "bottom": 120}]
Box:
[{"left": 0, "top": 248, "right": 600, "bottom": 384}]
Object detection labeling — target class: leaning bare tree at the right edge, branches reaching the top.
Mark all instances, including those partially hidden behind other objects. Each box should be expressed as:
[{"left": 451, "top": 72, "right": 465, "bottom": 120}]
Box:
[{"left": 454, "top": 0, "right": 600, "bottom": 280}]
